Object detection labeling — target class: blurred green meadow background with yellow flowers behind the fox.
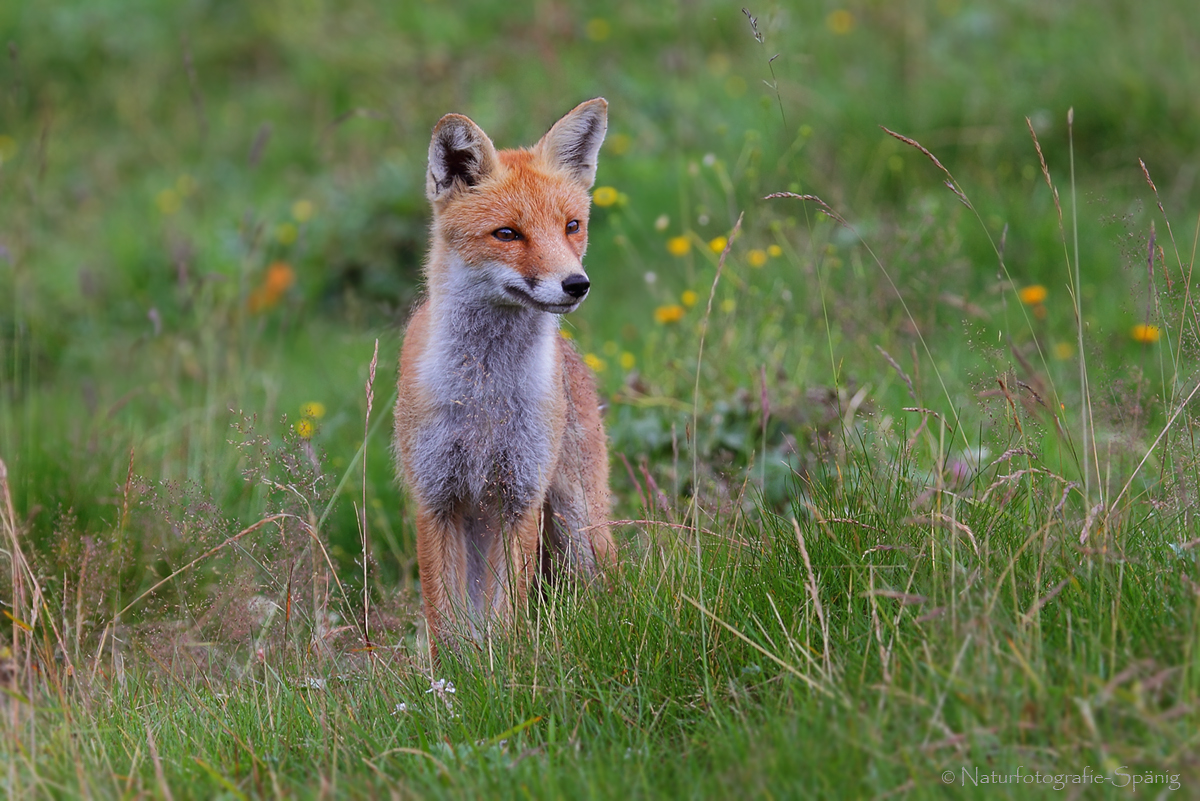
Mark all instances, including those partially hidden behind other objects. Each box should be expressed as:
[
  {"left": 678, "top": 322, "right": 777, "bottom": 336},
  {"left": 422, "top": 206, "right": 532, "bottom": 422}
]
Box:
[{"left": 0, "top": 0, "right": 1200, "bottom": 585}]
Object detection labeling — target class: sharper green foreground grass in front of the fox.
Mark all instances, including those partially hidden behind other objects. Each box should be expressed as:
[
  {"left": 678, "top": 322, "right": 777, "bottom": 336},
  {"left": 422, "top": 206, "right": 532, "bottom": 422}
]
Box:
[{"left": 5, "top": 398, "right": 1200, "bottom": 797}]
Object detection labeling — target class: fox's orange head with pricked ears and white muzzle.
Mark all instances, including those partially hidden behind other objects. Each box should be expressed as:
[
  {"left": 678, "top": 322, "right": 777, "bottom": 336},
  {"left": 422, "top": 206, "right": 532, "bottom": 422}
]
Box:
[{"left": 425, "top": 97, "right": 608, "bottom": 314}]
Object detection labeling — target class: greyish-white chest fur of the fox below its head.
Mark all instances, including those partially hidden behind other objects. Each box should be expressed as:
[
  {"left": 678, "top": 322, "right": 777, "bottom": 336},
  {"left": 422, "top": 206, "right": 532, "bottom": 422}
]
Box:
[{"left": 400, "top": 296, "right": 563, "bottom": 517}]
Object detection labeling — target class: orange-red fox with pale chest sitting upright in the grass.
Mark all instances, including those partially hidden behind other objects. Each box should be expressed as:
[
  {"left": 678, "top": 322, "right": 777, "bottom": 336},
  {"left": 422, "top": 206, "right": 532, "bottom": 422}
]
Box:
[{"left": 395, "top": 98, "right": 616, "bottom": 654}]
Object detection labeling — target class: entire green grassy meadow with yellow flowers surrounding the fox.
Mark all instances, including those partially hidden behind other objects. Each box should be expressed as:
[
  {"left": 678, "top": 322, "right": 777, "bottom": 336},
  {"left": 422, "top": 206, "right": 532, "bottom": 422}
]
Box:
[{"left": 0, "top": 0, "right": 1200, "bottom": 799}]
